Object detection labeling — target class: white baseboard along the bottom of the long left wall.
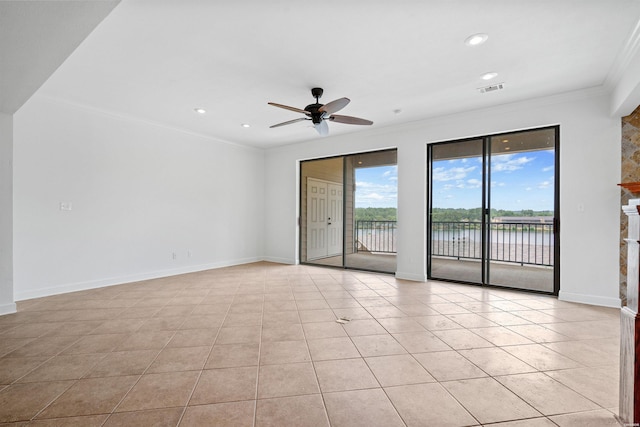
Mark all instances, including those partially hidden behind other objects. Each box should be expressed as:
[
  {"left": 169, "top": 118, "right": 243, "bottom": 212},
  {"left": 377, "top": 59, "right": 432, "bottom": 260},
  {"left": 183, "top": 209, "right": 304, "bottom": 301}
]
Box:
[{"left": 14, "top": 257, "right": 265, "bottom": 301}]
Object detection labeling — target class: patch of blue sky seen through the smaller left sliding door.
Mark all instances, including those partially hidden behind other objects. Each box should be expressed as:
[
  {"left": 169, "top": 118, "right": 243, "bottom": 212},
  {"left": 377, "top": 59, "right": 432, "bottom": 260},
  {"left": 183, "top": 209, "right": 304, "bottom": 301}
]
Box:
[{"left": 356, "top": 166, "right": 398, "bottom": 208}]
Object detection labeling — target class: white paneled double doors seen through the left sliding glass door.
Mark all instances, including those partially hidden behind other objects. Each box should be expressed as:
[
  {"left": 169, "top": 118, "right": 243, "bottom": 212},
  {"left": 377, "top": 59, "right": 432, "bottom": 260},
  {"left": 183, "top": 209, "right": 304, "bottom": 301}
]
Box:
[{"left": 307, "top": 178, "right": 343, "bottom": 260}]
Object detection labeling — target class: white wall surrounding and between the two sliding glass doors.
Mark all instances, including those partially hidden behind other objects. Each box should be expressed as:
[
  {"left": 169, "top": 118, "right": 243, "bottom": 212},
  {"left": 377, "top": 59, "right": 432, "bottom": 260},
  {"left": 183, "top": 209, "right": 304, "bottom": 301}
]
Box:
[{"left": 265, "top": 90, "right": 621, "bottom": 307}]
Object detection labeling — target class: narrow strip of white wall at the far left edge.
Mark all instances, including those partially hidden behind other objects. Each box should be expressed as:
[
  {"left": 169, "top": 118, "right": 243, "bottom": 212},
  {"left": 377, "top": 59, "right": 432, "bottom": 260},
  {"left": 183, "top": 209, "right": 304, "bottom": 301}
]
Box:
[{"left": 0, "top": 113, "right": 16, "bottom": 315}]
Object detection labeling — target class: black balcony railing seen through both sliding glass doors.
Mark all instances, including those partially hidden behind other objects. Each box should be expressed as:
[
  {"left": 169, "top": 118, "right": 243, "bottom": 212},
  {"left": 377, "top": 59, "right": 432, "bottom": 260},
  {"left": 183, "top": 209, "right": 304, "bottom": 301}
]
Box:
[{"left": 355, "top": 221, "right": 554, "bottom": 266}]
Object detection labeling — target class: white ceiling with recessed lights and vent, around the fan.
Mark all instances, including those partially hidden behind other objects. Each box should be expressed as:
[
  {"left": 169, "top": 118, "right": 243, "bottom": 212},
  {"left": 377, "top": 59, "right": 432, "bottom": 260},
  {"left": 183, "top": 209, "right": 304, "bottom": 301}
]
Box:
[{"left": 0, "top": 0, "right": 640, "bottom": 147}]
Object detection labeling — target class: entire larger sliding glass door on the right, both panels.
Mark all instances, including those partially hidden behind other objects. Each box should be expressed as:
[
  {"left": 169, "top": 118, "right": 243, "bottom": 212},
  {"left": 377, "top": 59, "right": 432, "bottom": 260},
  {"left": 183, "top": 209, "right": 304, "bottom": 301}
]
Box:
[{"left": 428, "top": 127, "right": 559, "bottom": 293}]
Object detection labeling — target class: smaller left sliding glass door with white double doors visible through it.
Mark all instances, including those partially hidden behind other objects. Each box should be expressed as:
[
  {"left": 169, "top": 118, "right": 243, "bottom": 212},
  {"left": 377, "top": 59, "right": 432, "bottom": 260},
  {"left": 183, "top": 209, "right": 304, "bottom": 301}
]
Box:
[{"left": 300, "top": 150, "right": 398, "bottom": 273}]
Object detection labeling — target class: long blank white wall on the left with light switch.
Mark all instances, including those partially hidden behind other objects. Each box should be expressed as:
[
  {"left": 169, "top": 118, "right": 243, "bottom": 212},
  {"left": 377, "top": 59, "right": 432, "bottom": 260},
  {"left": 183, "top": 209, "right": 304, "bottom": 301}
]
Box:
[{"left": 14, "top": 95, "right": 264, "bottom": 300}]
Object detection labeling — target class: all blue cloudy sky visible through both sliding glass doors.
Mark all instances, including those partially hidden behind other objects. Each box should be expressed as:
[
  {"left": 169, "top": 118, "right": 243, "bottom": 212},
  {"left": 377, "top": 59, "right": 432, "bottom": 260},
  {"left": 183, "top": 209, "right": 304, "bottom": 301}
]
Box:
[{"left": 356, "top": 150, "right": 555, "bottom": 211}]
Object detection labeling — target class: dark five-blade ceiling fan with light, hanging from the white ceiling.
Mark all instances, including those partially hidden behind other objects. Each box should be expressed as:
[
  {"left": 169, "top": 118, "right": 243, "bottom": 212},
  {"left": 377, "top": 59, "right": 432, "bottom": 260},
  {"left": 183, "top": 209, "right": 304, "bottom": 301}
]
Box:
[{"left": 268, "top": 87, "right": 373, "bottom": 136}]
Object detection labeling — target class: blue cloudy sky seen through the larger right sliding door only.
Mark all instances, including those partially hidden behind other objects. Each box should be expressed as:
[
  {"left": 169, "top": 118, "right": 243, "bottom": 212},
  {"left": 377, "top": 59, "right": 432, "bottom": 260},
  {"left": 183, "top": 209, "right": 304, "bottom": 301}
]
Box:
[{"left": 432, "top": 150, "right": 554, "bottom": 211}]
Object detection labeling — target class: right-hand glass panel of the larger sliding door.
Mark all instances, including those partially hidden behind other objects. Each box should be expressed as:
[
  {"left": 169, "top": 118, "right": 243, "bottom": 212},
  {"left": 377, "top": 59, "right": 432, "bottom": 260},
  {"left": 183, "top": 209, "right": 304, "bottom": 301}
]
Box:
[{"left": 487, "top": 128, "right": 557, "bottom": 292}]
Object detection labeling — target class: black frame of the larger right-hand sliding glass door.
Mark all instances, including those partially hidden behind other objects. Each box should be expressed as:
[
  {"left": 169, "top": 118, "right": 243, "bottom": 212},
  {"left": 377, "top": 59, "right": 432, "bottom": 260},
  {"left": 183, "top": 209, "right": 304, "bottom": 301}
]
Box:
[{"left": 426, "top": 125, "right": 560, "bottom": 296}]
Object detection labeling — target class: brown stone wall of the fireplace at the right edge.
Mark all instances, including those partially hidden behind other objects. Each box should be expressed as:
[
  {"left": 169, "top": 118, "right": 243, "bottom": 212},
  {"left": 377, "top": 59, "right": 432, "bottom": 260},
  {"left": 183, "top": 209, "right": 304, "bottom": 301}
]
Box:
[{"left": 620, "top": 106, "right": 640, "bottom": 305}]
